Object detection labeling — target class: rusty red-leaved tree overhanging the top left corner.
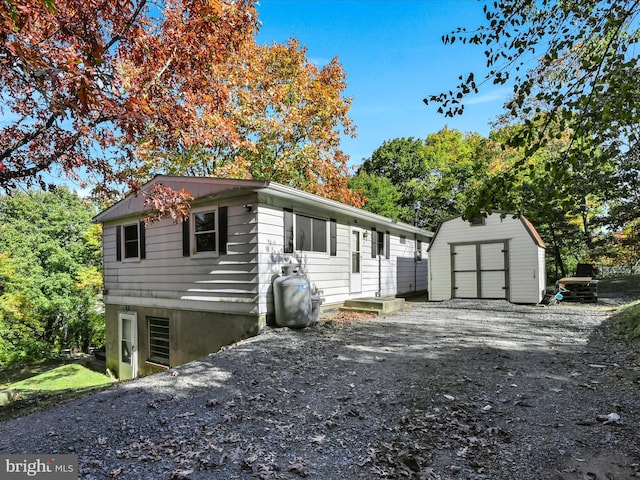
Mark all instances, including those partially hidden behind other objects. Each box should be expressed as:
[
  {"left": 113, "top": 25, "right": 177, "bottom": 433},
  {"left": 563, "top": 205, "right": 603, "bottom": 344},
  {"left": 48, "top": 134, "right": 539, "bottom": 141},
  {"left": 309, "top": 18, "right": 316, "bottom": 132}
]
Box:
[{"left": 0, "top": 0, "right": 248, "bottom": 189}]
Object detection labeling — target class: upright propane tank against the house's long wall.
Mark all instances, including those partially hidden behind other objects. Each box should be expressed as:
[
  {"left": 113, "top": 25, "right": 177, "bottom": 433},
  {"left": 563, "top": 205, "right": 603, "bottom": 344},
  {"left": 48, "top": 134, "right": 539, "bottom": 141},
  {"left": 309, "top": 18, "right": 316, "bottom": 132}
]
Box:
[{"left": 273, "top": 265, "right": 313, "bottom": 328}]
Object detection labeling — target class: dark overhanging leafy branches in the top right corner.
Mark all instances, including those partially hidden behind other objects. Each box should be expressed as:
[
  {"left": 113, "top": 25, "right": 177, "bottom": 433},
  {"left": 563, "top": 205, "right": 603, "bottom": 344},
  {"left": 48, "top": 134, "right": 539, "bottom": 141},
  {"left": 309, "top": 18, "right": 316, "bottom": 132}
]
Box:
[{"left": 425, "top": 0, "right": 640, "bottom": 216}]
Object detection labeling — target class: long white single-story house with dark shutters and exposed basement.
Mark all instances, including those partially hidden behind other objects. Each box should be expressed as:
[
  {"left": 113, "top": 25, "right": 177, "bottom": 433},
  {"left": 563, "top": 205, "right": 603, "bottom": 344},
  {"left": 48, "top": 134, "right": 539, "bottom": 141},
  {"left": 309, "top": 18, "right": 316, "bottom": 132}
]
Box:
[{"left": 94, "top": 176, "right": 433, "bottom": 378}]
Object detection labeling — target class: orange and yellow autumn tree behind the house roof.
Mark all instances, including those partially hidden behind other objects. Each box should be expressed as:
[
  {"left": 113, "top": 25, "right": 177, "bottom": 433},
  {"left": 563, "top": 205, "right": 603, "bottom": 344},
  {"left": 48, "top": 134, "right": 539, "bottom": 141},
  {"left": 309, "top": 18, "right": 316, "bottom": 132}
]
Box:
[{"left": 146, "top": 40, "right": 361, "bottom": 205}]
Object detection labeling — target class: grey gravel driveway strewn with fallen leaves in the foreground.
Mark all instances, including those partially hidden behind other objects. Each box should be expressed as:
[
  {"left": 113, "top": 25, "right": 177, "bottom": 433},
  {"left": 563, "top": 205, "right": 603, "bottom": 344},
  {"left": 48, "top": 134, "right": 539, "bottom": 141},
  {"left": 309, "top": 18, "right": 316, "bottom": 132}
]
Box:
[{"left": 0, "top": 301, "right": 640, "bottom": 480}]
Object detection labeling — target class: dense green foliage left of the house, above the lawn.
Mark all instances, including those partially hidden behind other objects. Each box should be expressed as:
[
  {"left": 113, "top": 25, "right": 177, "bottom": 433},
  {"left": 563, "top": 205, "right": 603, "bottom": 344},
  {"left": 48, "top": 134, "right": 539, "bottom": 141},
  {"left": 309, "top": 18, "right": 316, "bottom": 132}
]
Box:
[{"left": 0, "top": 188, "right": 104, "bottom": 362}]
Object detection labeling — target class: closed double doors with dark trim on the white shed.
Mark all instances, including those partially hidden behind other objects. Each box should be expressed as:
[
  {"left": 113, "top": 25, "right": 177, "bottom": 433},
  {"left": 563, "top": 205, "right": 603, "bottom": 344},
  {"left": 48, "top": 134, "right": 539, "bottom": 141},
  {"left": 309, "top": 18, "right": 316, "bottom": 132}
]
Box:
[{"left": 451, "top": 240, "right": 509, "bottom": 300}]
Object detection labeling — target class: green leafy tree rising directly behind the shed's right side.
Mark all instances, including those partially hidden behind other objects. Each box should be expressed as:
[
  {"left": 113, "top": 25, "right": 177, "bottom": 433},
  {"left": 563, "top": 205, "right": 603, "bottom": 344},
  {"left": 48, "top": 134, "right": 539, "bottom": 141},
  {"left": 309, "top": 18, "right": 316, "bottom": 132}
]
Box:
[{"left": 484, "top": 126, "right": 615, "bottom": 278}]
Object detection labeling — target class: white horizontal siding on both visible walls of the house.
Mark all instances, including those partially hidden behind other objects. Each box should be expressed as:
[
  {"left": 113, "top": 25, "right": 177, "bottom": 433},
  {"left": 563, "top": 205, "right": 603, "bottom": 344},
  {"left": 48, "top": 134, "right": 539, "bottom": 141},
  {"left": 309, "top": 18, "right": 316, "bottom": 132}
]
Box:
[{"left": 104, "top": 189, "right": 428, "bottom": 315}]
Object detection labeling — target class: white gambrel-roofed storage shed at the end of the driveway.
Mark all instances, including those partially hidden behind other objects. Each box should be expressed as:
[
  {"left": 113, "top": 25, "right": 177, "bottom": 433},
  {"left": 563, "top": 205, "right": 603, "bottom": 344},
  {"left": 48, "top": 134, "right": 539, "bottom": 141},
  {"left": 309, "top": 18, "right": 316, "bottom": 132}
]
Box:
[{"left": 428, "top": 212, "right": 546, "bottom": 303}]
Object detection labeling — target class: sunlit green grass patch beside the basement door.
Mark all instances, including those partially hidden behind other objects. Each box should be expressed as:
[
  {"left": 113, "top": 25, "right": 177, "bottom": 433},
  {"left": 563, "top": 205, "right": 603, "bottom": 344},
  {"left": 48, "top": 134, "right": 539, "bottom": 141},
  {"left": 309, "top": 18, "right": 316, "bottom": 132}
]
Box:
[{"left": 0, "top": 362, "right": 113, "bottom": 421}]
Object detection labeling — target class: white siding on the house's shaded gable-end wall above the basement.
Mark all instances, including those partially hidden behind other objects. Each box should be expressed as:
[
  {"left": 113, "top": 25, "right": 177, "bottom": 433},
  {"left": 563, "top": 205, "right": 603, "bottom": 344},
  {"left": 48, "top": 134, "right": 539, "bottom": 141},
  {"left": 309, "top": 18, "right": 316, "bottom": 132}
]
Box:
[{"left": 104, "top": 204, "right": 259, "bottom": 313}]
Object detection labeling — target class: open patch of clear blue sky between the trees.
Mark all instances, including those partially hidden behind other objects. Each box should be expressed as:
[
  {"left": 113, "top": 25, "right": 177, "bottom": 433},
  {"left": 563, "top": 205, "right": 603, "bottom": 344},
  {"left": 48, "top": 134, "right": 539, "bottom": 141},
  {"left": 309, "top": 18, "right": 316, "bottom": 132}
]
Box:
[{"left": 258, "top": 0, "right": 509, "bottom": 171}]
